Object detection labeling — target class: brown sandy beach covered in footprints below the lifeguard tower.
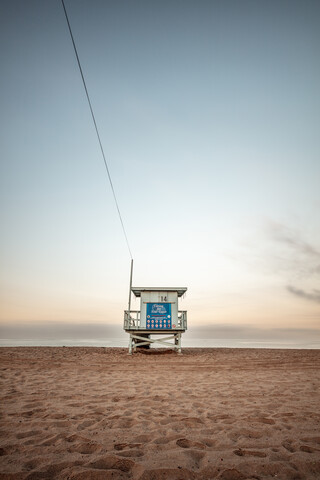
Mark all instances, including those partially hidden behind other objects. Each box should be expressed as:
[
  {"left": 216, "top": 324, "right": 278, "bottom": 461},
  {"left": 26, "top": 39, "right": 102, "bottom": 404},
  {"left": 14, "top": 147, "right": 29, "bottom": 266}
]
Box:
[{"left": 0, "top": 347, "right": 320, "bottom": 480}]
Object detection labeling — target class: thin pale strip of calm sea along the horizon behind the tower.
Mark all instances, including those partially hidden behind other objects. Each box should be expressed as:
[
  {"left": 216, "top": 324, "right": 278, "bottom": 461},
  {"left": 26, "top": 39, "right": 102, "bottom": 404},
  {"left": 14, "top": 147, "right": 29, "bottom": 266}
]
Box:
[{"left": 0, "top": 337, "right": 320, "bottom": 349}]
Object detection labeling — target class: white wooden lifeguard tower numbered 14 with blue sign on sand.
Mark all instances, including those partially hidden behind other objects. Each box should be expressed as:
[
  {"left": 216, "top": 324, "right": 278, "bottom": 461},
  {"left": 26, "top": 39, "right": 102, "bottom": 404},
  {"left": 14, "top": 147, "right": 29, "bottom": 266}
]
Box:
[{"left": 123, "top": 287, "right": 187, "bottom": 355}]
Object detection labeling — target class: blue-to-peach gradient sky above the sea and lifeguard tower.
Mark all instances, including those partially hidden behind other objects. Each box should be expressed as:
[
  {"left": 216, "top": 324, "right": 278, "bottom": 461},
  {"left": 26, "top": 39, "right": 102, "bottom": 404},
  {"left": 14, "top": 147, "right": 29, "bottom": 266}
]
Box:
[{"left": 0, "top": 0, "right": 320, "bottom": 346}]
